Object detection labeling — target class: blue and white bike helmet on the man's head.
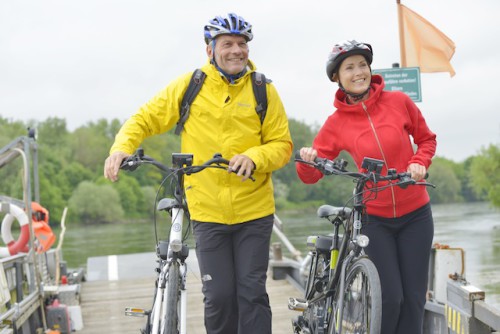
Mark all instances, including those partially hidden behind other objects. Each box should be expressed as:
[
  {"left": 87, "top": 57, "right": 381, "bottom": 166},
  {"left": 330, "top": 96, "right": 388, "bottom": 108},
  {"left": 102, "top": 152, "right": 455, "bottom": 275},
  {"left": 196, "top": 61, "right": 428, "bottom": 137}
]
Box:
[{"left": 204, "top": 13, "right": 253, "bottom": 44}]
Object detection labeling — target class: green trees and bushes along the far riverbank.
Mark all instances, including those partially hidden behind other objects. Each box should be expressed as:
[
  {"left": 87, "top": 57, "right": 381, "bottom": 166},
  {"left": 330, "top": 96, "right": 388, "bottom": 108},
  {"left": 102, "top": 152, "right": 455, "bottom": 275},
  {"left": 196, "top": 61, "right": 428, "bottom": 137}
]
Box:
[{"left": 0, "top": 116, "right": 500, "bottom": 224}]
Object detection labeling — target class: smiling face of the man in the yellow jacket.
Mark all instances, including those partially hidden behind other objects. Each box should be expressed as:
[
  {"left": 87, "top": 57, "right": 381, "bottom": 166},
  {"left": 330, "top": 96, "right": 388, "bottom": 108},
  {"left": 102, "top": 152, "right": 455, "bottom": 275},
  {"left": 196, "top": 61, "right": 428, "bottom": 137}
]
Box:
[{"left": 207, "top": 35, "right": 249, "bottom": 75}]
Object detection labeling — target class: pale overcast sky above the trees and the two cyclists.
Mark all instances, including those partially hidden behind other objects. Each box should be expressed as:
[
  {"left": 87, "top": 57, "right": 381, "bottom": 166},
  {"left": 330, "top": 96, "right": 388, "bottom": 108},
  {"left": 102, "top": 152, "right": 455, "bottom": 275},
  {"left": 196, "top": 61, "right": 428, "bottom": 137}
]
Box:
[{"left": 0, "top": 0, "right": 500, "bottom": 162}]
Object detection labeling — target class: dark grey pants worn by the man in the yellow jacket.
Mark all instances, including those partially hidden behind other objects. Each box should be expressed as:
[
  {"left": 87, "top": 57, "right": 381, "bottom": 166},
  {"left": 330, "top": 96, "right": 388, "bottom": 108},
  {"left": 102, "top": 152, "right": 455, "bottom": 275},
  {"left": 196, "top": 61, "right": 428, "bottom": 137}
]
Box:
[{"left": 193, "top": 215, "right": 274, "bottom": 334}]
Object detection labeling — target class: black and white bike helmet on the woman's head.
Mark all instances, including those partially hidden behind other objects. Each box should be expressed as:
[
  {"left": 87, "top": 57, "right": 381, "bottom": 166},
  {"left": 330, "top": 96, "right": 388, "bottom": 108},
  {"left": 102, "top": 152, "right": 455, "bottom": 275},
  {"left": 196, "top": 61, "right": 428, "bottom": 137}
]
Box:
[{"left": 326, "top": 40, "right": 373, "bottom": 81}]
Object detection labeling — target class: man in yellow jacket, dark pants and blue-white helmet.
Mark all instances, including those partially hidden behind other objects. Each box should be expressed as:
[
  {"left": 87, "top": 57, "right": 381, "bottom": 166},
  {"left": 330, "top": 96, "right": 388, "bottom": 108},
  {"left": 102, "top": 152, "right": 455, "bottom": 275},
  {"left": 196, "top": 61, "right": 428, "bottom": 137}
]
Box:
[{"left": 104, "top": 13, "right": 293, "bottom": 334}]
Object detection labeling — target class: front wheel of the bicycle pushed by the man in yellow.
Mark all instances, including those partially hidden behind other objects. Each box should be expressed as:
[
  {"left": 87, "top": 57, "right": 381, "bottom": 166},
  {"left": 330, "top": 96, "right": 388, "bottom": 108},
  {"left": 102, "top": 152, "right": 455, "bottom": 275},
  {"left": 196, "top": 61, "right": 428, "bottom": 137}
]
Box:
[{"left": 163, "top": 261, "right": 181, "bottom": 334}]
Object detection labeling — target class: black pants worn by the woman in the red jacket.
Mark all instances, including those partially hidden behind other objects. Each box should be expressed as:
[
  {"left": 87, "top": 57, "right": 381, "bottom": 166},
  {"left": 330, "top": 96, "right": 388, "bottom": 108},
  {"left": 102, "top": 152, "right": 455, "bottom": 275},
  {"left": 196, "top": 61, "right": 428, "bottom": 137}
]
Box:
[{"left": 362, "top": 204, "right": 434, "bottom": 334}]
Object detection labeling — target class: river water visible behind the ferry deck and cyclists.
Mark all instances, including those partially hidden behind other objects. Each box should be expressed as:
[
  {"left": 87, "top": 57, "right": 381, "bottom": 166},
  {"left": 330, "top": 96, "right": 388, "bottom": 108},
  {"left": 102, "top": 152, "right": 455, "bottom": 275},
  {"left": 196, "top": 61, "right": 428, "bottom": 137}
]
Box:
[{"left": 59, "top": 203, "right": 500, "bottom": 309}]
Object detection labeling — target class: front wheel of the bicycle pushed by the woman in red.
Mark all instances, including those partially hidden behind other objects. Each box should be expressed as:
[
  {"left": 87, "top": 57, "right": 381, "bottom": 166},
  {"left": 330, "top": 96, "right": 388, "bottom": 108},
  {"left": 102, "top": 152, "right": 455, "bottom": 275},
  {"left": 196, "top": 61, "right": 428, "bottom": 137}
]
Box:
[{"left": 329, "top": 258, "right": 382, "bottom": 334}]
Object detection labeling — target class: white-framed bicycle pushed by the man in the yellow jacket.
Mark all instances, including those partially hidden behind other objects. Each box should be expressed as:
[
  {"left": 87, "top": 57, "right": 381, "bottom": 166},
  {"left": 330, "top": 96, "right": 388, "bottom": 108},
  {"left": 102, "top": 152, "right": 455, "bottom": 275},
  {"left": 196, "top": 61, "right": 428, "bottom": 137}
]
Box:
[{"left": 120, "top": 149, "right": 246, "bottom": 334}]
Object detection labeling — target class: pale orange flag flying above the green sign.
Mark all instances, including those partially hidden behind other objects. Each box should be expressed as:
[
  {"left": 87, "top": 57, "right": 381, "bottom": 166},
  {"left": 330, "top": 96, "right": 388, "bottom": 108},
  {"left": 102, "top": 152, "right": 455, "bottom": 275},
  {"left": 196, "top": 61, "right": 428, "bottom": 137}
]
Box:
[{"left": 398, "top": 1, "right": 455, "bottom": 76}]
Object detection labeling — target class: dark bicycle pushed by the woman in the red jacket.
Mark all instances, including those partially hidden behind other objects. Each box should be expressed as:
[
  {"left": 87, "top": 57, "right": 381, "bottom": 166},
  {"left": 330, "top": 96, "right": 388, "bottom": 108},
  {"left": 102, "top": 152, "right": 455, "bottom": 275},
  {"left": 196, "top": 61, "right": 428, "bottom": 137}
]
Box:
[{"left": 288, "top": 153, "right": 434, "bottom": 334}]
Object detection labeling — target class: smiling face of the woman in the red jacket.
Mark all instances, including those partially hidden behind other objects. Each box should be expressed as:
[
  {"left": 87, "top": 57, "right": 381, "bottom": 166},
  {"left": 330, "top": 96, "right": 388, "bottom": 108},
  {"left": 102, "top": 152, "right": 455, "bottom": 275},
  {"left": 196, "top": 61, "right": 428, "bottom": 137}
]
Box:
[{"left": 337, "top": 55, "right": 372, "bottom": 94}]
